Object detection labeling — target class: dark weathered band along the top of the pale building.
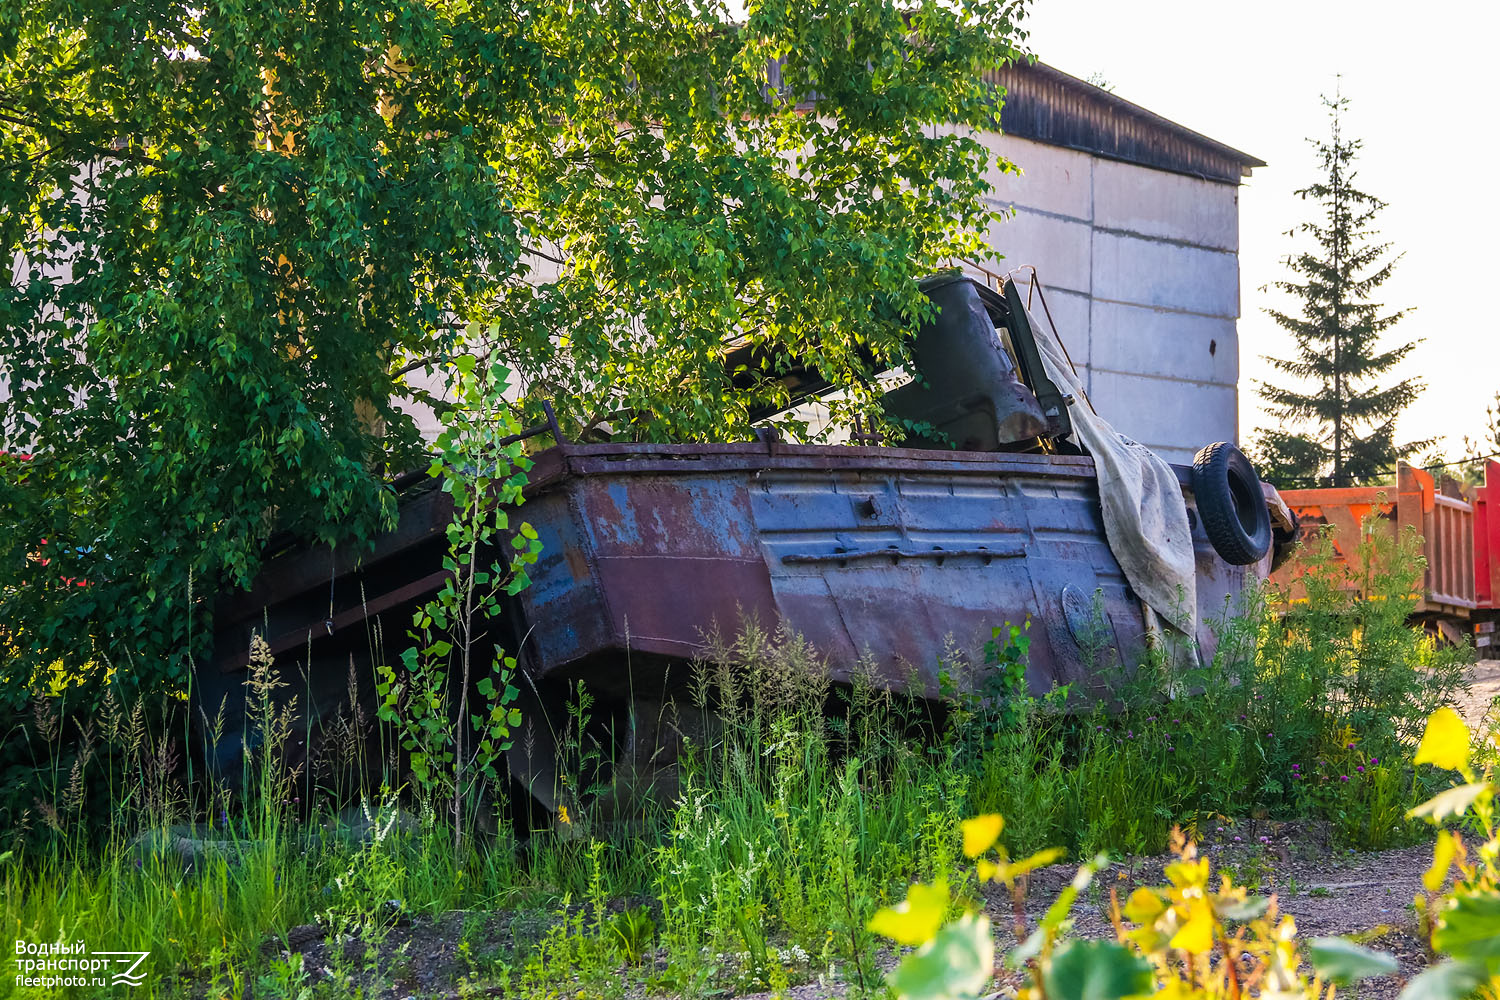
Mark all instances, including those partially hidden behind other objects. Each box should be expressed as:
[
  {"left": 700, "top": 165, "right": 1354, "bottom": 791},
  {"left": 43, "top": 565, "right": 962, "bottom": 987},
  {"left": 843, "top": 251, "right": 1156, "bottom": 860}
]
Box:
[{"left": 986, "top": 63, "right": 1266, "bottom": 184}]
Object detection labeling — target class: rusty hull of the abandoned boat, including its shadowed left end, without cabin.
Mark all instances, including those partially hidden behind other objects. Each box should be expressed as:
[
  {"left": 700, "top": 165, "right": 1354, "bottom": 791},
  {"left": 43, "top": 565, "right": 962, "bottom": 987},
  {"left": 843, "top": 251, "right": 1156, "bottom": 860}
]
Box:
[{"left": 194, "top": 441, "right": 1256, "bottom": 808}]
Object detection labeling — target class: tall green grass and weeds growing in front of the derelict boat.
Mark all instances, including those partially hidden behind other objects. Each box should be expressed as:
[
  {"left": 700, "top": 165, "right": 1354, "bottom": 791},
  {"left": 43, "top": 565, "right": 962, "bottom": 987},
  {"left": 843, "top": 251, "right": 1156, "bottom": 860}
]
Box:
[{"left": 0, "top": 521, "right": 1466, "bottom": 1000}]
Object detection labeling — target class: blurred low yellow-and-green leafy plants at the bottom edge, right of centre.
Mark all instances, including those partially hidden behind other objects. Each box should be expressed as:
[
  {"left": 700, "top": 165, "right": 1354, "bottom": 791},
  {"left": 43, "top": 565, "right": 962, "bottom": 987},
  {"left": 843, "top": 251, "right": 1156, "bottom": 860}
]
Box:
[{"left": 870, "top": 816, "right": 1397, "bottom": 1000}]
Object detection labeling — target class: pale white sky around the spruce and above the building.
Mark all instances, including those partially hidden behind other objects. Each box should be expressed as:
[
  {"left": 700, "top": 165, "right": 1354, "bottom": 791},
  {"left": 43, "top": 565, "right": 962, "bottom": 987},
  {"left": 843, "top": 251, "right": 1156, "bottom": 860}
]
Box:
[{"left": 1028, "top": 0, "right": 1500, "bottom": 459}]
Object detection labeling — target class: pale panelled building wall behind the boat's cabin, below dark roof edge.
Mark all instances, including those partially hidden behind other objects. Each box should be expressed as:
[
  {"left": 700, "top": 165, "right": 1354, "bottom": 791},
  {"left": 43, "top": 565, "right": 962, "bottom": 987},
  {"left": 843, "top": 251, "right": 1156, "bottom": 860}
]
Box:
[{"left": 981, "top": 133, "right": 1239, "bottom": 463}]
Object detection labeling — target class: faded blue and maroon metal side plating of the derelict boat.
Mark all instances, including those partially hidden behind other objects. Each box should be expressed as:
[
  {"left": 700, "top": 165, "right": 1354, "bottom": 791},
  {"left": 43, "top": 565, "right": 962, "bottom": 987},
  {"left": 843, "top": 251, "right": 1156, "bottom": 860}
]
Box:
[{"left": 521, "top": 444, "right": 1244, "bottom": 694}]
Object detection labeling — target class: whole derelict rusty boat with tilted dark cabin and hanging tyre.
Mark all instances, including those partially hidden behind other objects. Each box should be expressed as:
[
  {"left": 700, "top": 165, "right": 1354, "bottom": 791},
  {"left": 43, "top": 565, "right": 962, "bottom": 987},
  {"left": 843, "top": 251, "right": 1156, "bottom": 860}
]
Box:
[{"left": 195, "top": 274, "right": 1295, "bottom": 807}]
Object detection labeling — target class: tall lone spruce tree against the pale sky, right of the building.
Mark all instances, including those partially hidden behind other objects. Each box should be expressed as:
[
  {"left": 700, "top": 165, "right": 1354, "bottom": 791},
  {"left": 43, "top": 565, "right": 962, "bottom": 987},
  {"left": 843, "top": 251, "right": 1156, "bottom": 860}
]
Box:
[{"left": 1257, "top": 96, "right": 1431, "bottom": 486}]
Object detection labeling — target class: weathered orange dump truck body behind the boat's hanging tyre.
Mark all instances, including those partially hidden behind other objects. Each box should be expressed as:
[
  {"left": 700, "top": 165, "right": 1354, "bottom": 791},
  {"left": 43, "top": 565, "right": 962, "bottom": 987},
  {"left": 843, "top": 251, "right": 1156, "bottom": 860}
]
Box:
[{"left": 1272, "top": 462, "right": 1482, "bottom": 637}]
